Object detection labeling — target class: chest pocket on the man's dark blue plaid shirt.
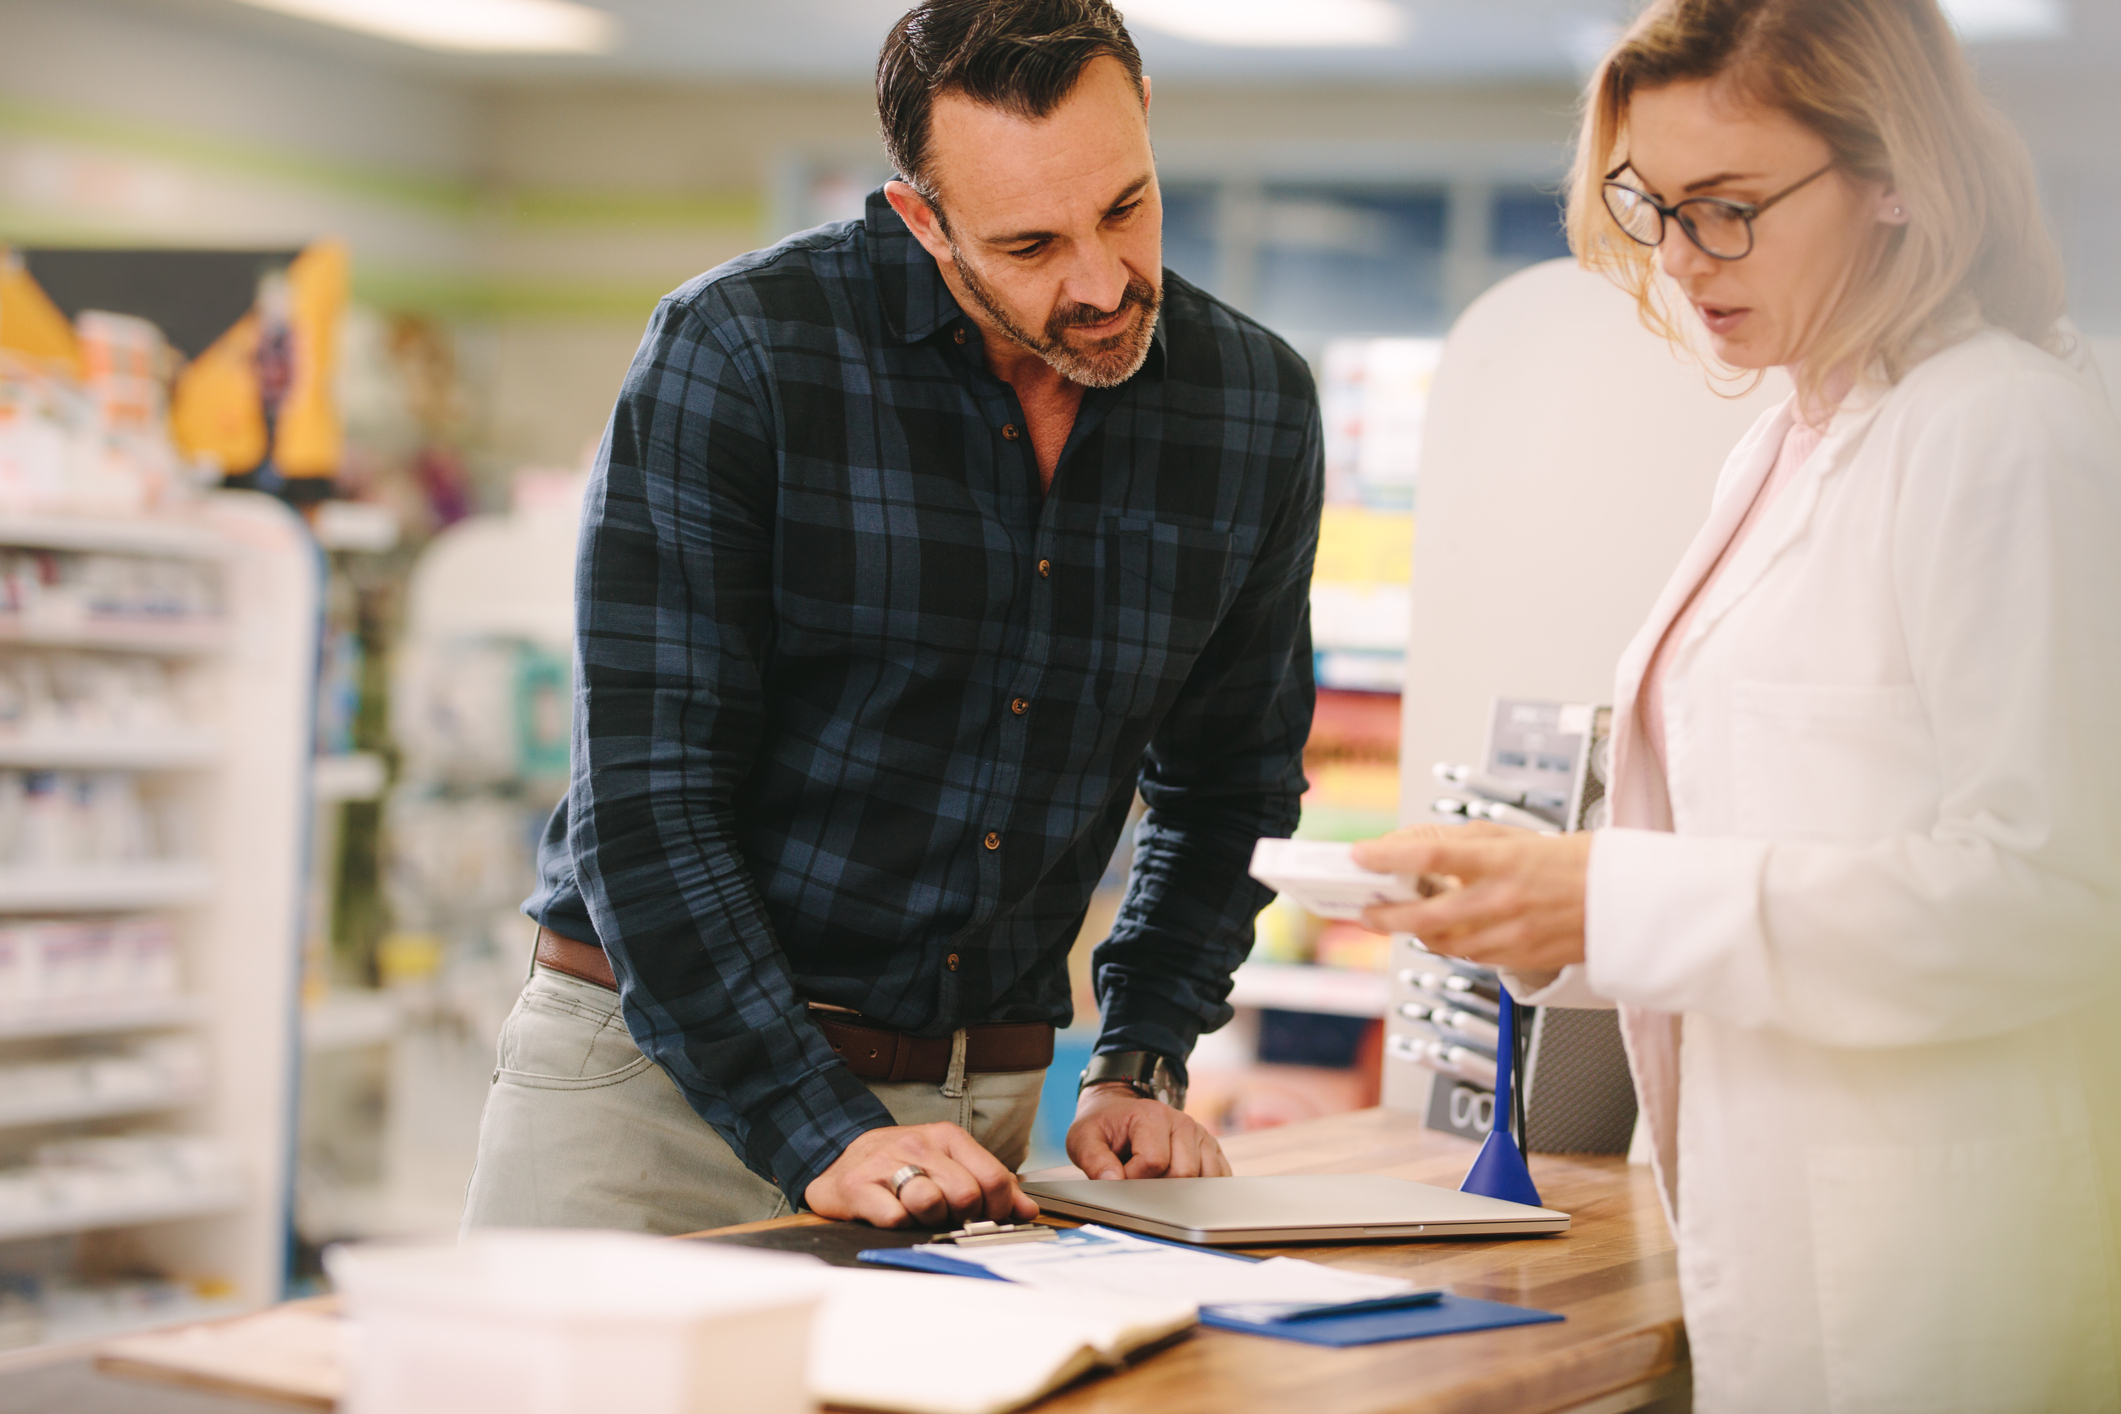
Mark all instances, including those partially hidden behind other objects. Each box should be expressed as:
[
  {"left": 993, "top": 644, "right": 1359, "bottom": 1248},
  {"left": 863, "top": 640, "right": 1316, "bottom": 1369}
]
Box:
[{"left": 1094, "top": 515, "right": 1239, "bottom": 717}]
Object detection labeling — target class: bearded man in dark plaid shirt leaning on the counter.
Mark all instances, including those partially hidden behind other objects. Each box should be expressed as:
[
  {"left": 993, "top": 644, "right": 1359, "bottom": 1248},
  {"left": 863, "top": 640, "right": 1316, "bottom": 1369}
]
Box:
[{"left": 464, "top": 0, "right": 1321, "bottom": 1232}]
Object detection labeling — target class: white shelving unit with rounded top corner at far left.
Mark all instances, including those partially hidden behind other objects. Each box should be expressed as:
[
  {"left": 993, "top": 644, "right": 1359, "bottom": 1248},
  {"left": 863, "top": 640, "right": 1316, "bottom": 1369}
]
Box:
[{"left": 0, "top": 502, "right": 320, "bottom": 1336}]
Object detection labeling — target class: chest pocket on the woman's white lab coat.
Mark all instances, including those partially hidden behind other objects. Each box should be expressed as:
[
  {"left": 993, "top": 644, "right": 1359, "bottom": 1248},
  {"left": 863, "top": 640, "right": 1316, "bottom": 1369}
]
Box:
[{"left": 1731, "top": 681, "right": 1939, "bottom": 842}]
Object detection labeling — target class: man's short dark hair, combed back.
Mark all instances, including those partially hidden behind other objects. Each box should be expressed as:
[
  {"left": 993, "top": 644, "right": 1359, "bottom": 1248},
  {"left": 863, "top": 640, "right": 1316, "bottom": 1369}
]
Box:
[{"left": 876, "top": 0, "right": 1141, "bottom": 216}]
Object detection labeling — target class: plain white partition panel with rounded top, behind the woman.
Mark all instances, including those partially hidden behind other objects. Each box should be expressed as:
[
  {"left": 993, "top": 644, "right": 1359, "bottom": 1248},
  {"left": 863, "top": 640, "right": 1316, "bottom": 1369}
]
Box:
[{"left": 1385, "top": 261, "right": 1788, "bottom": 1109}]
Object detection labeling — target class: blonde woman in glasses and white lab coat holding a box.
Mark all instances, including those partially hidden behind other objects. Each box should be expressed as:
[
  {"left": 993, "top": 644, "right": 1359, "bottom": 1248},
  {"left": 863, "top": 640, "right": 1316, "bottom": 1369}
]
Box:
[{"left": 1357, "top": 0, "right": 2121, "bottom": 1414}]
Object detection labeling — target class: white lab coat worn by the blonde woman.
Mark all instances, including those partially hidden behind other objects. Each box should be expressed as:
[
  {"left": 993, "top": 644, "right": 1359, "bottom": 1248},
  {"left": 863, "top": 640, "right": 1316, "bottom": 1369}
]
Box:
[{"left": 1527, "top": 331, "right": 2121, "bottom": 1414}]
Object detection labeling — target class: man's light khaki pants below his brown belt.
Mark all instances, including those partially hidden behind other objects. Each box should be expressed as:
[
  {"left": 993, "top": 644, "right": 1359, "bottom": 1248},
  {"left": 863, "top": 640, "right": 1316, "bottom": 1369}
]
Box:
[{"left": 464, "top": 967, "right": 1046, "bottom": 1234}]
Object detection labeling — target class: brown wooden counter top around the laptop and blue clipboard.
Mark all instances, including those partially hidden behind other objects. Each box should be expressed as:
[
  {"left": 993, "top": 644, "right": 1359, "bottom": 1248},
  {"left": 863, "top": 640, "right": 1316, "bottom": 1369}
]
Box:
[{"left": 704, "top": 1109, "right": 1686, "bottom": 1414}]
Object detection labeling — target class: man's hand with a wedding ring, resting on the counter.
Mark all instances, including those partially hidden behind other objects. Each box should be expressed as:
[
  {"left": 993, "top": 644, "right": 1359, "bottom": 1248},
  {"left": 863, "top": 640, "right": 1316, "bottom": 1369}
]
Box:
[{"left": 804, "top": 1124, "right": 1039, "bottom": 1227}]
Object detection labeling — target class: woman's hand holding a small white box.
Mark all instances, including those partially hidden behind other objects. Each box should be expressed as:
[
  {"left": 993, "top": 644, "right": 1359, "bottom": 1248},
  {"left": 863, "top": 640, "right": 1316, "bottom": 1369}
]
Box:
[{"left": 1355, "top": 823, "right": 1591, "bottom": 973}]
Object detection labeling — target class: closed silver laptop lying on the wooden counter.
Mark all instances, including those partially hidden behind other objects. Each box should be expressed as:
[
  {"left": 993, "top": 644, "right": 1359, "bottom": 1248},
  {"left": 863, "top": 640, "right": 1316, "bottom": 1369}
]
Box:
[{"left": 1024, "top": 1174, "right": 1570, "bottom": 1247}]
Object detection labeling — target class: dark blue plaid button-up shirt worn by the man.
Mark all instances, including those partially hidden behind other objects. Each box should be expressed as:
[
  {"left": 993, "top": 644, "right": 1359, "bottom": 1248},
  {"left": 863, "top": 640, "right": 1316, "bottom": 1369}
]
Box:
[{"left": 524, "top": 193, "right": 1321, "bottom": 1204}]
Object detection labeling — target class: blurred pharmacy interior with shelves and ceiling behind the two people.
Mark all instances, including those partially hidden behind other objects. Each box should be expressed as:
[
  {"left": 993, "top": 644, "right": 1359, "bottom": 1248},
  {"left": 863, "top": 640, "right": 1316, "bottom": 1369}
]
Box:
[{"left": 0, "top": 0, "right": 2121, "bottom": 1346}]
